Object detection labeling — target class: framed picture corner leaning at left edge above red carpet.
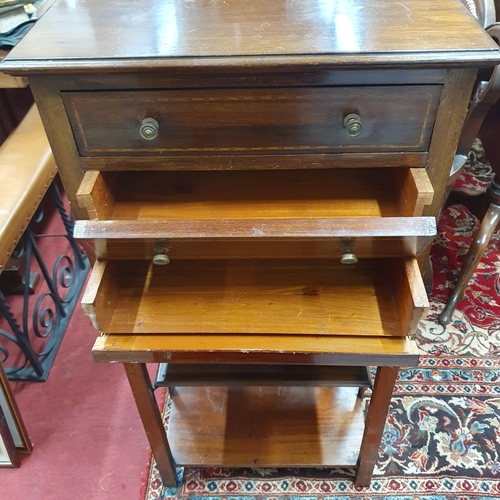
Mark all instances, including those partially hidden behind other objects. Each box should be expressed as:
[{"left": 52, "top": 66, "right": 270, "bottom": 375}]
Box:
[{"left": 0, "top": 362, "right": 33, "bottom": 460}]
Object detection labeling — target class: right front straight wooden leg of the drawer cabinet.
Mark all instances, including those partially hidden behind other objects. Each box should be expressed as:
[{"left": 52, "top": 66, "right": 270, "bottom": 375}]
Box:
[{"left": 354, "top": 366, "right": 399, "bottom": 487}]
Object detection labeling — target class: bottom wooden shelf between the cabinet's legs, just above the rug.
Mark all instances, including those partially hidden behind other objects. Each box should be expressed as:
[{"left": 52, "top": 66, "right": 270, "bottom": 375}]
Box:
[{"left": 167, "top": 387, "right": 364, "bottom": 467}]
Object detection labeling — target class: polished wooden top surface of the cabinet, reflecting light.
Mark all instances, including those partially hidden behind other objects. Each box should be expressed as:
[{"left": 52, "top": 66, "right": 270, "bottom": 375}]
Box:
[{"left": 6, "top": 0, "right": 499, "bottom": 70}]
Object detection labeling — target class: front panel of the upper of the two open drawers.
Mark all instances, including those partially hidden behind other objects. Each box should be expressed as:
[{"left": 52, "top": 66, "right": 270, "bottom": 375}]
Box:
[{"left": 75, "top": 221, "right": 436, "bottom": 262}]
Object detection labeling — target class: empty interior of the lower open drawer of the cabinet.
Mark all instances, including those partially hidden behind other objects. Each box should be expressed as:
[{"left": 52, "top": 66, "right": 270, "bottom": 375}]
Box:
[{"left": 82, "top": 259, "right": 427, "bottom": 336}]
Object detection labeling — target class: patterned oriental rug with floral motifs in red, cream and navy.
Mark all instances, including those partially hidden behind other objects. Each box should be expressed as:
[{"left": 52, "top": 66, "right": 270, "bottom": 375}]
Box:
[{"left": 146, "top": 142, "right": 500, "bottom": 500}]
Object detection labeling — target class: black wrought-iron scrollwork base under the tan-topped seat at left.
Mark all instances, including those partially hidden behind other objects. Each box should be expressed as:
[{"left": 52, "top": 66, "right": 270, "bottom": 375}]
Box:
[{"left": 0, "top": 182, "right": 90, "bottom": 381}]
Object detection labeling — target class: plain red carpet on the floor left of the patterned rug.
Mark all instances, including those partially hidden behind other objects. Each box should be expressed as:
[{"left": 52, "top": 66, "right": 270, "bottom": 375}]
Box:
[{"left": 0, "top": 188, "right": 163, "bottom": 500}]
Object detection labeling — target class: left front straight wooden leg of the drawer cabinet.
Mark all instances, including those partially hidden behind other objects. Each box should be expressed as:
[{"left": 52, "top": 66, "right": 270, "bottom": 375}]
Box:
[{"left": 124, "top": 363, "right": 177, "bottom": 486}]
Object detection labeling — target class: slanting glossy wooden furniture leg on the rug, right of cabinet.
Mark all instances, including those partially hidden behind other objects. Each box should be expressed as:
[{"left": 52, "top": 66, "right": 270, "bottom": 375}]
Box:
[{"left": 438, "top": 203, "right": 500, "bottom": 325}]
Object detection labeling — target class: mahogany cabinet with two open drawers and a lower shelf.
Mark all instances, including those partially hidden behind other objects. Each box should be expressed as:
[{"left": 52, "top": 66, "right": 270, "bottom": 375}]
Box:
[{"left": 3, "top": 0, "right": 500, "bottom": 486}]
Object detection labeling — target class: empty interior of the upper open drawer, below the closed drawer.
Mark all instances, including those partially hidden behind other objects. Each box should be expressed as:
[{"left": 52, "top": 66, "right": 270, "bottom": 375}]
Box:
[{"left": 77, "top": 168, "right": 434, "bottom": 220}]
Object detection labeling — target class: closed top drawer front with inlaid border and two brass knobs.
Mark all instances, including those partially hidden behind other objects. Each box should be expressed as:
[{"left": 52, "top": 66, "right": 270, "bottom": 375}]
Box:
[{"left": 63, "top": 85, "right": 441, "bottom": 156}]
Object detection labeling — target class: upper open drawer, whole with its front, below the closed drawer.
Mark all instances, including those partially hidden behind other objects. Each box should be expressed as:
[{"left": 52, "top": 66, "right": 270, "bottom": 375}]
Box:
[{"left": 75, "top": 169, "right": 436, "bottom": 259}]
